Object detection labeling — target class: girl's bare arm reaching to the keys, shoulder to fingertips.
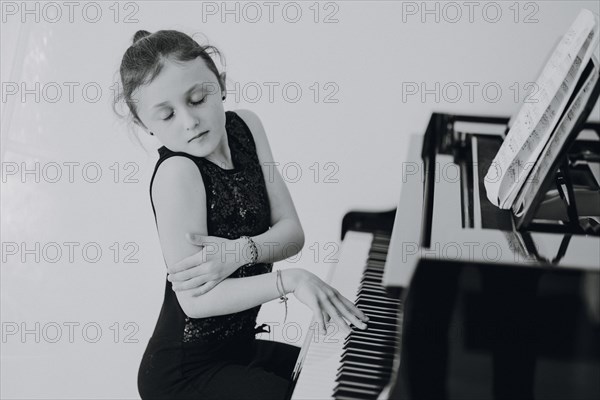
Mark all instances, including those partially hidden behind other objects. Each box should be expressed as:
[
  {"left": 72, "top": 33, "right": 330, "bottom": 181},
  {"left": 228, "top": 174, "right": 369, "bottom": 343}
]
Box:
[{"left": 152, "top": 156, "right": 366, "bottom": 332}]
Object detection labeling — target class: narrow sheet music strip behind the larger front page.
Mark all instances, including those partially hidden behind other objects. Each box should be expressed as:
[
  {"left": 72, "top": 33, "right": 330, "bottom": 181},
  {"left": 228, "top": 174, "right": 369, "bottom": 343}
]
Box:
[{"left": 513, "top": 56, "right": 599, "bottom": 217}]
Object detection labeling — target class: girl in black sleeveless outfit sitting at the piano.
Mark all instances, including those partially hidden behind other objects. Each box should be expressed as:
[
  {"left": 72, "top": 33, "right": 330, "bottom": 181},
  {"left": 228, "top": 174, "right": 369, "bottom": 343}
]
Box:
[{"left": 112, "top": 30, "right": 366, "bottom": 400}]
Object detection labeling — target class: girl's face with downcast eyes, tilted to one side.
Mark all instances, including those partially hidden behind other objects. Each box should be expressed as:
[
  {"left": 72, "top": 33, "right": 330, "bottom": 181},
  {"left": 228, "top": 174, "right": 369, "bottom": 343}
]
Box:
[{"left": 132, "top": 57, "right": 227, "bottom": 157}]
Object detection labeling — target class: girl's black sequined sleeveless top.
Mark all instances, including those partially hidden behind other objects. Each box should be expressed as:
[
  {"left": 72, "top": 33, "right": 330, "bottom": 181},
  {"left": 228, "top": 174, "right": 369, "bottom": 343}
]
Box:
[{"left": 150, "top": 111, "right": 273, "bottom": 345}]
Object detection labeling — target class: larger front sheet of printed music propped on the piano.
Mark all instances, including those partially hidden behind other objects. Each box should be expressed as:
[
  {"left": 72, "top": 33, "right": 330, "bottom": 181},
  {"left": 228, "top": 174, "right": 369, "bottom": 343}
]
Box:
[{"left": 485, "top": 9, "right": 598, "bottom": 208}]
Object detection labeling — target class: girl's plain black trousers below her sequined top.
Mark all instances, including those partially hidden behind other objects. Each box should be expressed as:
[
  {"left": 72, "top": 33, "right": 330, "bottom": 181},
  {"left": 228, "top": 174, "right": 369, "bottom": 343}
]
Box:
[{"left": 138, "top": 338, "right": 300, "bottom": 400}]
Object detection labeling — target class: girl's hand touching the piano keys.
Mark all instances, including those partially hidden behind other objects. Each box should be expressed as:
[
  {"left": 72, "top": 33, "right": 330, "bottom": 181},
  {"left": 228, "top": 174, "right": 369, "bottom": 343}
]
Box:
[{"left": 293, "top": 270, "right": 369, "bottom": 334}]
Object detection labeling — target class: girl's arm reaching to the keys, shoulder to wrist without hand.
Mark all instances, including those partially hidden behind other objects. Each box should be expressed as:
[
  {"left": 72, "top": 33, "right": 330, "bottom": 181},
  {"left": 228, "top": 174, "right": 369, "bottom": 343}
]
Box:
[{"left": 152, "top": 156, "right": 298, "bottom": 318}]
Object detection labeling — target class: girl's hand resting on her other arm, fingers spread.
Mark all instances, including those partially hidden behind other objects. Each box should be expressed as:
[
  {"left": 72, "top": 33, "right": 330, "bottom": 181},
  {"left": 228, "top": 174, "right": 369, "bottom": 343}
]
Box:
[{"left": 167, "top": 234, "right": 245, "bottom": 296}]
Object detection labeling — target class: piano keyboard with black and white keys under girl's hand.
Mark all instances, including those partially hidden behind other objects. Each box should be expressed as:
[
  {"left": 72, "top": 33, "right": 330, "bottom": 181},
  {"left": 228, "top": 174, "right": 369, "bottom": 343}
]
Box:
[{"left": 291, "top": 231, "right": 402, "bottom": 400}]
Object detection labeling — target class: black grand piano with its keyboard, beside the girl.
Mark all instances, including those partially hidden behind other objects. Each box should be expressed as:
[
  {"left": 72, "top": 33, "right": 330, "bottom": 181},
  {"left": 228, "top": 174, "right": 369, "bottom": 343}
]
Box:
[{"left": 288, "top": 113, "right": 600, "bottom": 400}]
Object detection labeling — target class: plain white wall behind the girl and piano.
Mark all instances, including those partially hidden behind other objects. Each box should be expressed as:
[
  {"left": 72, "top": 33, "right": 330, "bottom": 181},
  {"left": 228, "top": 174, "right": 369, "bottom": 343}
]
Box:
[{"left": 0, "top": 1, "right": 599, "bottom": 399}]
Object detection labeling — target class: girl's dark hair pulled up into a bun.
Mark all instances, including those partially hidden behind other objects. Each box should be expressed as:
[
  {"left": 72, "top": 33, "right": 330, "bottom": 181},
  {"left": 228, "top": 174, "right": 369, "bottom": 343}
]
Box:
[{"left": 113, "top": 30, "right": 225, "bottom": 148}]
